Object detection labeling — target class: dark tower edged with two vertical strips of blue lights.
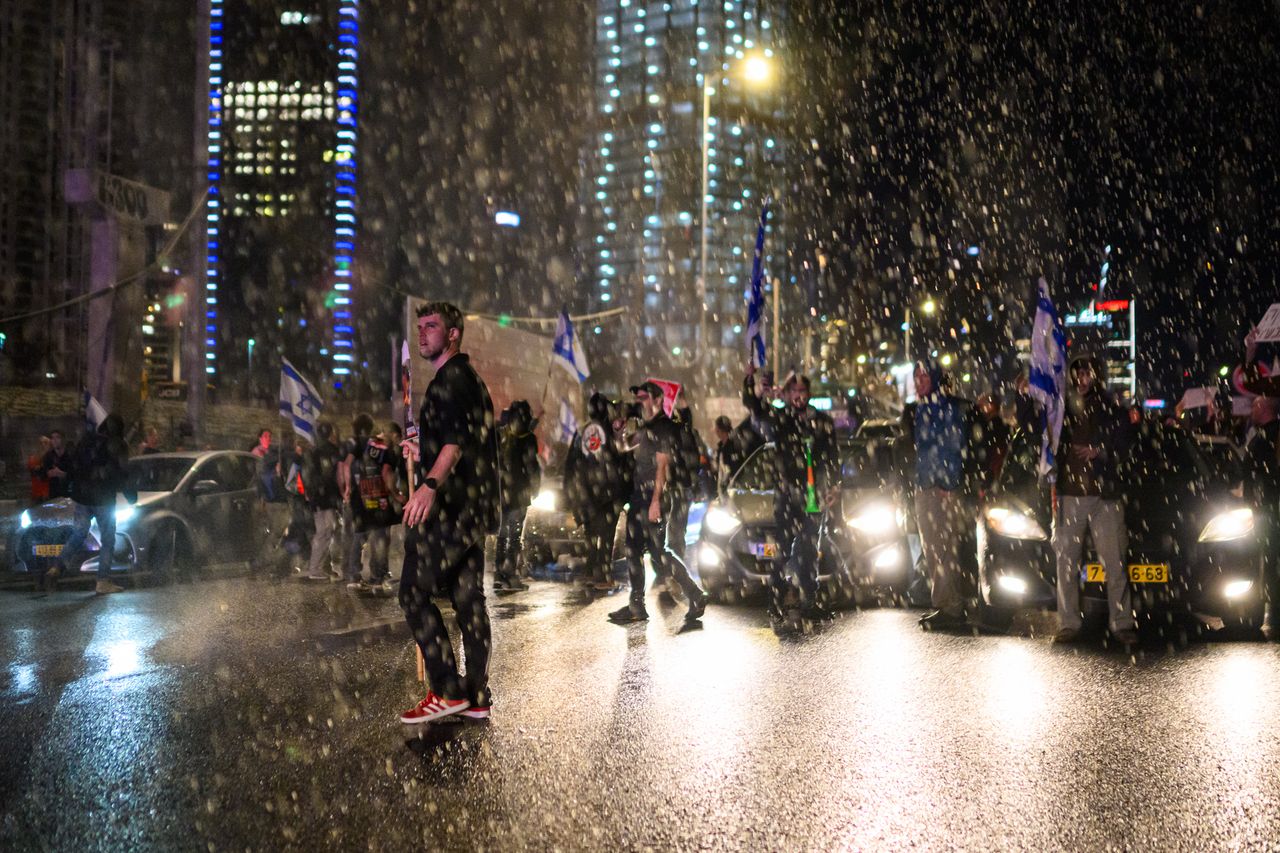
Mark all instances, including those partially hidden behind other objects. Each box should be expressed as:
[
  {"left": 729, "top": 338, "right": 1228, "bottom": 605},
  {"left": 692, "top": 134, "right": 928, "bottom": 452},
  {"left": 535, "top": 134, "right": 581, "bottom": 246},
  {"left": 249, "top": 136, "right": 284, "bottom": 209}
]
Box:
[{"left": 204, "top": 0, "right": 360, "bottom": 396}]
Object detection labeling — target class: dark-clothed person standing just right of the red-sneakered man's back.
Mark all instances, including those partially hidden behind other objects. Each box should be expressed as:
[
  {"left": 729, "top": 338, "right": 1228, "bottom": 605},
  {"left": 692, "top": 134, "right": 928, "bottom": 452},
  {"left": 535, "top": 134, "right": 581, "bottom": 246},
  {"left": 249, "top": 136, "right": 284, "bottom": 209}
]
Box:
[{"left": 493, "top": 400, "right": 543, "bottom": 592}]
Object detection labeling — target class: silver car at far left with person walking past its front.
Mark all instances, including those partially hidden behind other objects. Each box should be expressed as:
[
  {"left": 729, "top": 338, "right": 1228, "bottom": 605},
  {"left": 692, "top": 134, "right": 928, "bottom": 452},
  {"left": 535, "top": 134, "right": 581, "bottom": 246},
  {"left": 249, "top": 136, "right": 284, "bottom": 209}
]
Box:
[{"left": 15, "top": 451, "right": 266, "bottom": 576}]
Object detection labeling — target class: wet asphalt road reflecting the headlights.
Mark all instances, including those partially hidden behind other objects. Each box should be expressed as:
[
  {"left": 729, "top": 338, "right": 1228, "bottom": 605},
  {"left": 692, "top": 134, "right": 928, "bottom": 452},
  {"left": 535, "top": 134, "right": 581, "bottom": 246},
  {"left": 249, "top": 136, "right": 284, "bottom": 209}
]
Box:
[{"left": 0, "top": 563, "right": 1280, "bottom": 850}]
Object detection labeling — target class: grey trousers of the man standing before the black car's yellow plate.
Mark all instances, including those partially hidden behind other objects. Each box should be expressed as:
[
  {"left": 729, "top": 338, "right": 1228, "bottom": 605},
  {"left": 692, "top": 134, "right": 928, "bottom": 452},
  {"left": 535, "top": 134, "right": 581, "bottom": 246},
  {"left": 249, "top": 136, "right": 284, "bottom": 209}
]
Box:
[{"left": 1053, "top": 496, "right": 1138, "bottom": 640}]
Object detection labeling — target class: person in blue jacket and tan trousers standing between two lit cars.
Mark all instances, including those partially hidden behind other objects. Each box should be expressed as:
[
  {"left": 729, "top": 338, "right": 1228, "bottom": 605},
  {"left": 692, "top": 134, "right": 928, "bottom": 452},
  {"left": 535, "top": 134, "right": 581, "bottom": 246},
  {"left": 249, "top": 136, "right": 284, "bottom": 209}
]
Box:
[{"left": 902, "top": 360, "right": 974, "bottom": 630}]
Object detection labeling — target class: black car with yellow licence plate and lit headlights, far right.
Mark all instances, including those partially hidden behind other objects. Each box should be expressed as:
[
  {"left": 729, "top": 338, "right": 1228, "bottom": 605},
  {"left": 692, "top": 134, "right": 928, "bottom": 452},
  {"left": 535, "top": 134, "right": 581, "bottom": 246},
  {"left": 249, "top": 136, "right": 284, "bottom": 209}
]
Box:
[{"left": 977, "top": 423, "right": 1263, "bottom": 628}]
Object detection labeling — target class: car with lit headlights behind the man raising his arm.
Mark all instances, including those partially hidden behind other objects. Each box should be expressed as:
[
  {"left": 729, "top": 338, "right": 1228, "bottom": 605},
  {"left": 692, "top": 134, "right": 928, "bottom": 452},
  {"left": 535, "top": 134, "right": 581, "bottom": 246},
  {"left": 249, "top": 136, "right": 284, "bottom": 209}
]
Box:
[{"left": 696, "top": 439, "right": 911, "bottom": 603}]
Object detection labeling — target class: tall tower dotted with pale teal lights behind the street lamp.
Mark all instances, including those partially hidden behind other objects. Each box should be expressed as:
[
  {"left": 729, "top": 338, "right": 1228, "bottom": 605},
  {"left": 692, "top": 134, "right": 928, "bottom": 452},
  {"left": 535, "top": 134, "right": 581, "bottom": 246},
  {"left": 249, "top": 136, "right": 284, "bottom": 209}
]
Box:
[{"left": 584, "top": 0, "right": 794, "bottom": 386}]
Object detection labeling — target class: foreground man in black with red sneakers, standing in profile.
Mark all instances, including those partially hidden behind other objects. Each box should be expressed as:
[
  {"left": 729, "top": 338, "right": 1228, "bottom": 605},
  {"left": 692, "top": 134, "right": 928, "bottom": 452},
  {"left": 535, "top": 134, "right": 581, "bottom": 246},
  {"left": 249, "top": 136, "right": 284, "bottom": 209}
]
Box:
[{"left": 399, "top": 302, "right": 502, "bottom": 724}]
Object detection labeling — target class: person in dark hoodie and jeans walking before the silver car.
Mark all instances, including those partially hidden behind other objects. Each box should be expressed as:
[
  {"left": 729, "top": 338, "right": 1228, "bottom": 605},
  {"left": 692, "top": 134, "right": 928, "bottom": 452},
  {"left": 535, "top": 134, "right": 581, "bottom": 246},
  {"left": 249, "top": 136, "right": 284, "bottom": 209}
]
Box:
[{"left": 59, "top": 414, "right": 138, "bottom": 596}]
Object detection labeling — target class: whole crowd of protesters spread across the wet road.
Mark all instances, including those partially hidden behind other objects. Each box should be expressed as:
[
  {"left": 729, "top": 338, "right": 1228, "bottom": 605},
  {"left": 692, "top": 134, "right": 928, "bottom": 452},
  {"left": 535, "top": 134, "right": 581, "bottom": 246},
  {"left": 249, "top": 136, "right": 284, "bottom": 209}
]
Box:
[{"left": 17, "top": 302, "right": 1280, "bottom": 722}]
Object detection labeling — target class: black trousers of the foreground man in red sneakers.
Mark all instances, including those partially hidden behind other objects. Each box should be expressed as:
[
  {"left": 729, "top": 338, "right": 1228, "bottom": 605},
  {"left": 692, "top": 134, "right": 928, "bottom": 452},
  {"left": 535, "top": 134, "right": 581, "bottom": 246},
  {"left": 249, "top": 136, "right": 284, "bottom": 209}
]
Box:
[{"left": 399, "top": 525, "right": 493, "bottom": 707}]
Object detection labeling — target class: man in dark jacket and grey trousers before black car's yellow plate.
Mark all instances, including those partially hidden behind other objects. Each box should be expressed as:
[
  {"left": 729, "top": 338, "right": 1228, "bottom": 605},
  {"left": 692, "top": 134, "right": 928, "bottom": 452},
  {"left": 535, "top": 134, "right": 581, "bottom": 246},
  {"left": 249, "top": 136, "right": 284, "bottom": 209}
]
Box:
[{"left": 1053, "top": 356, "right": 1138, "bottom": 646}]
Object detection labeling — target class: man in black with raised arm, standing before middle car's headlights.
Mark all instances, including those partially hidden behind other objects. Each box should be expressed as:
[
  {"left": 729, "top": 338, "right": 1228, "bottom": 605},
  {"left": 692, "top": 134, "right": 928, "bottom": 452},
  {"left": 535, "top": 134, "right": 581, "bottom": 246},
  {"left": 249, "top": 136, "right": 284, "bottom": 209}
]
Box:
[{"left": 742, "top": 366, "right": 840, "bottom": 621}]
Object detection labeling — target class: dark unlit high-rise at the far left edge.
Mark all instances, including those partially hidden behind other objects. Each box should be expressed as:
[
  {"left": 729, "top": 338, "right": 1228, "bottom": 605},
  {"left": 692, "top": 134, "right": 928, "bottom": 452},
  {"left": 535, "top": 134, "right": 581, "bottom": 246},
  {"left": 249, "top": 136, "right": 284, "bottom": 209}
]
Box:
[{"left": 0, "top": 0, "right": 195, "bottom": 386}]
